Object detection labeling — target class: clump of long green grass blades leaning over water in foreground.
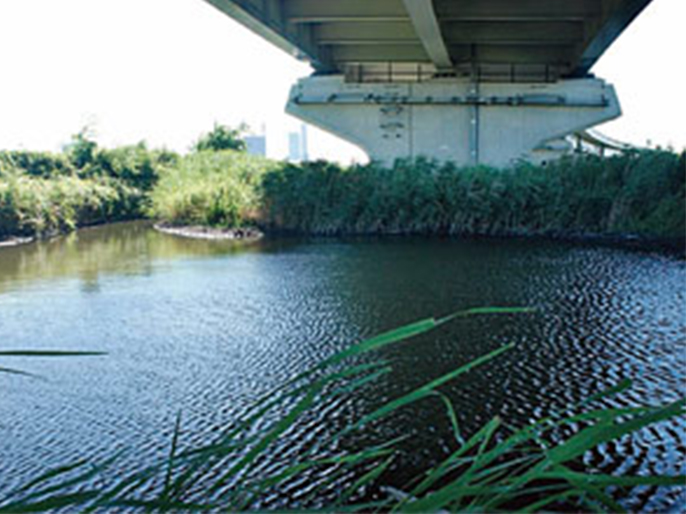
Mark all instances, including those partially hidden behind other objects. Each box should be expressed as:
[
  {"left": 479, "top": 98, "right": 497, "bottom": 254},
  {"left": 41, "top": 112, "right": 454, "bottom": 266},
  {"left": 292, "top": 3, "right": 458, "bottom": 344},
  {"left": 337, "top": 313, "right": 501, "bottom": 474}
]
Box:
[{"left": 0, "top": 308, "right": 686, "bottom": 513}]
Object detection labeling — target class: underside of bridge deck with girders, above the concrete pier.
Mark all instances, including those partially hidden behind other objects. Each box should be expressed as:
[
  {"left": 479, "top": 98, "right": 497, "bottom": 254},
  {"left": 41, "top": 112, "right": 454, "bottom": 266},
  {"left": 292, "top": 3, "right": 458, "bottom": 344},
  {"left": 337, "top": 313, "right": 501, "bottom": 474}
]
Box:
[{"left": 206, "top": 0, "right": 651, "bottom": 81}]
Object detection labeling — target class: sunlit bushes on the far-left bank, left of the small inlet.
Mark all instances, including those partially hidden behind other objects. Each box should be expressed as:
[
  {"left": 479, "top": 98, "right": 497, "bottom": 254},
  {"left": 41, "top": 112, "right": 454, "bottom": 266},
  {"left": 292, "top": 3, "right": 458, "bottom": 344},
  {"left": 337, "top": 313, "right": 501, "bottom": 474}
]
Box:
[{"left": 0, "top": 140, "right": 178, "bottom": 240}]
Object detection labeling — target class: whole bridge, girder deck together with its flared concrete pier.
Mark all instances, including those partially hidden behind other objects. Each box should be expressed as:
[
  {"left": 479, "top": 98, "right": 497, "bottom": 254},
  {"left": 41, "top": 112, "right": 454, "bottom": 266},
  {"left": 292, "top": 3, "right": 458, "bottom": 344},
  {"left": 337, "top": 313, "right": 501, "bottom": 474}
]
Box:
[{"left": 206, "top": 0, "right": 651, "bottom": 166}]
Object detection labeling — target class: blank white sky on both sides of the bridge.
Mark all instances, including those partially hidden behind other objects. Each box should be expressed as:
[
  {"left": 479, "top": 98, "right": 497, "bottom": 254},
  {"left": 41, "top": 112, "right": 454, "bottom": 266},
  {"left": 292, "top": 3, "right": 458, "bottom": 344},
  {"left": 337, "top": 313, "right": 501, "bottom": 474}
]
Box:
[{"left": 0, "top": 0, "right": 686, "bottom": 162}]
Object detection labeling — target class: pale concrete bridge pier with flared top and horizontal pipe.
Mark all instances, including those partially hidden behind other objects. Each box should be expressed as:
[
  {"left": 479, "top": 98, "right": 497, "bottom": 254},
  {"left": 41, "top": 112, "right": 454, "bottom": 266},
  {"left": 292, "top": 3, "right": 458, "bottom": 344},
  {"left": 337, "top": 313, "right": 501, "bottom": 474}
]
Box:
[{"left": 286, "top": 75, "right": 621, "bottom": 166}]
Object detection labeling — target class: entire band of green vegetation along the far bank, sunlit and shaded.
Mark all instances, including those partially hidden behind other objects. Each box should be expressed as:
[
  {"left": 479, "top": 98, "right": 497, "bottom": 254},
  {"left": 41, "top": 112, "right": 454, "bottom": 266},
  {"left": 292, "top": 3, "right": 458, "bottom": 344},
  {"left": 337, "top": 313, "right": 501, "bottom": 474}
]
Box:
[{"left": 0, "top": 126, "right": 686, "bottom": 241}]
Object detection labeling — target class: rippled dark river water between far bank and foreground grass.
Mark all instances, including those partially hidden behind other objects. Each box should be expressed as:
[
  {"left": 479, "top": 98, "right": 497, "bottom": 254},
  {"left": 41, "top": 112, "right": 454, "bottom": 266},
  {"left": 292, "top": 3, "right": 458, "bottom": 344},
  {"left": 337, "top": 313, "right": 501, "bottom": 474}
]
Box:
[{"left": 0, "top": 220, "right": 686, "bottom": 510}]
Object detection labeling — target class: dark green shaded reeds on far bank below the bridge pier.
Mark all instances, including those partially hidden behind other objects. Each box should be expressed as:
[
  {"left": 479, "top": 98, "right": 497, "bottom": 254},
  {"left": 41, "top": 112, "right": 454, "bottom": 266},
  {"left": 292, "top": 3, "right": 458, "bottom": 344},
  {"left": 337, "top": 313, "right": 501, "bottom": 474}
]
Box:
[{"left": 262, "top": 151, "right": 686, "bottom": 239}]
